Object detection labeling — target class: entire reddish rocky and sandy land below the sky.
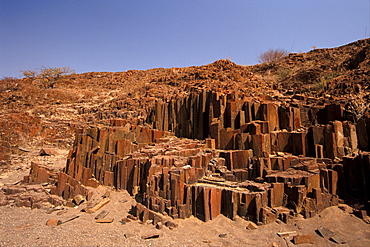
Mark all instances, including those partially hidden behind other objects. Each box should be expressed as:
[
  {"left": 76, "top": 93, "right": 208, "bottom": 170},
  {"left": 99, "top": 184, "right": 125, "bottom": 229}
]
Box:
[{"left": 0, "top": 39, "right": 370, "bottom": 246}]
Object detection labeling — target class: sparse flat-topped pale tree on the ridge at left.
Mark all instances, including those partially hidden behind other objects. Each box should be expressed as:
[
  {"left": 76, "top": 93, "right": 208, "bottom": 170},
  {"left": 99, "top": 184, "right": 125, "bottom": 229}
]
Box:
[{"left": 21, "top": 67, "right": 74, "bottom": 88}]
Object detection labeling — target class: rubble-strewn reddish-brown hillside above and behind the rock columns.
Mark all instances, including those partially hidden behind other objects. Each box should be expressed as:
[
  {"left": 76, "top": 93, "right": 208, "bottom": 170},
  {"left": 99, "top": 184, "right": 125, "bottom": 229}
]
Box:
[{"left": 0, "top": 39, "right": 370, "bottom": 152}]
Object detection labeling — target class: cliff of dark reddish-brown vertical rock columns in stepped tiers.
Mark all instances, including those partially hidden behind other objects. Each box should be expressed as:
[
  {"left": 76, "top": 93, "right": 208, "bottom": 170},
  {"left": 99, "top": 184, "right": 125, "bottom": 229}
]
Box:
[{"left": 51, "top": 89, "right": 370, "bottom": 224}]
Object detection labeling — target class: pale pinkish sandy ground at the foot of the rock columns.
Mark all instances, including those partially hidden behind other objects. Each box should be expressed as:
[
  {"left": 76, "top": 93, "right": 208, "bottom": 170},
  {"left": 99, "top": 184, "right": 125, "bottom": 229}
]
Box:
[{"left": 0, "top": 150, "right": 370, "bottom": 247}]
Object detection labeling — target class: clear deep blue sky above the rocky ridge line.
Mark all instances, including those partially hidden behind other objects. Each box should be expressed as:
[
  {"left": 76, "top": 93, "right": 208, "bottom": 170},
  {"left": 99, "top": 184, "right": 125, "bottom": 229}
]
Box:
[{"left": 0, "top": 0, "right": 370, "bottom": 78}]
